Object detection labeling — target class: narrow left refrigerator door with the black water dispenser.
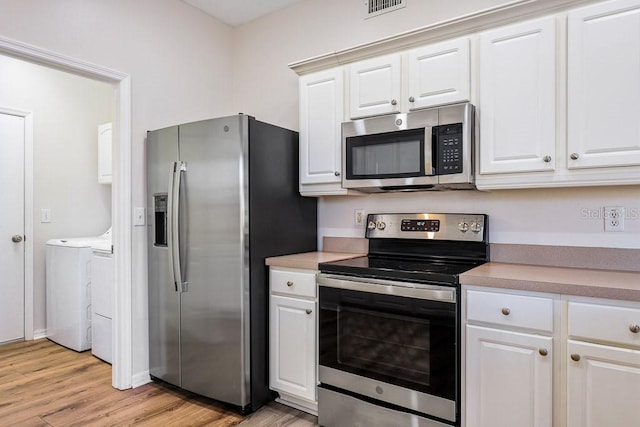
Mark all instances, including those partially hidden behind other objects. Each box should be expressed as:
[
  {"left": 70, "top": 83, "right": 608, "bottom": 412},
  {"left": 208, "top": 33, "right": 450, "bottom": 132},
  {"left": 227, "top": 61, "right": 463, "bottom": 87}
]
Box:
[{"left": 147, "top": 126, "right": 180, "bottom": 386}]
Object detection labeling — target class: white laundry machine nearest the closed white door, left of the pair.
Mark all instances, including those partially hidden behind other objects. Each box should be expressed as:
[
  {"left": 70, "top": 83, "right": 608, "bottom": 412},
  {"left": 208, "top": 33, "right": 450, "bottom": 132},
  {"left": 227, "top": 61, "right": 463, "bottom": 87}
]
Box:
[{"left": 45, "top": 231, "right": 111, "bottom": 351}]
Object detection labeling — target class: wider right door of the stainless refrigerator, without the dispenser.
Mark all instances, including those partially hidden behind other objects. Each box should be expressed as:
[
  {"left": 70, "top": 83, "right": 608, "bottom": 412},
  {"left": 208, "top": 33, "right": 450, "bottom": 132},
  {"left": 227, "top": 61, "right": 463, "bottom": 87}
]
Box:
[{"left": 179, "top": 116, "right": 250, "bottom": 407}]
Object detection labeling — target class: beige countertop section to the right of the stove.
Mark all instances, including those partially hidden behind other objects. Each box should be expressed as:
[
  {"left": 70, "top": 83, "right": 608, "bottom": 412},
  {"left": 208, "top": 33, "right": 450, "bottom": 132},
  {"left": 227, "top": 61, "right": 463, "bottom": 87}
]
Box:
[{"left": 460, "top": 262, "right": 640, "bottom": 301}]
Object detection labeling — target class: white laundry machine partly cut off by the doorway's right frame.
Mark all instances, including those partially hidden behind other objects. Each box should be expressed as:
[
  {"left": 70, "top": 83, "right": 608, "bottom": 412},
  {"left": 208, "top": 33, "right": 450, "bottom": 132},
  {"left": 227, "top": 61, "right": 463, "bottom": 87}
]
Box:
[{"left": 91, "top": 239, "right": 115, "bottom": 363}]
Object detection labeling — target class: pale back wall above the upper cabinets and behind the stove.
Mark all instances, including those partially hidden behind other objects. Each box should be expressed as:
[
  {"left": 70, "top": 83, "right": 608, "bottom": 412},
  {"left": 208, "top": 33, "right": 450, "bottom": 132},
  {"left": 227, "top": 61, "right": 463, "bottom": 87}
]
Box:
[{"left": 234, "top": 0, "right": 640, "bottom": 248}]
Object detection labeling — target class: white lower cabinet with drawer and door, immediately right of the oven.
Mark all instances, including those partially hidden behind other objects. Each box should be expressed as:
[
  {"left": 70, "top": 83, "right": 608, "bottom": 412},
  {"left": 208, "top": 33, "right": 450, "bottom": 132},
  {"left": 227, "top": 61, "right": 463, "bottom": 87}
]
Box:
[{"left": 464, "top": 290, "right": 554, "bottom": 427}]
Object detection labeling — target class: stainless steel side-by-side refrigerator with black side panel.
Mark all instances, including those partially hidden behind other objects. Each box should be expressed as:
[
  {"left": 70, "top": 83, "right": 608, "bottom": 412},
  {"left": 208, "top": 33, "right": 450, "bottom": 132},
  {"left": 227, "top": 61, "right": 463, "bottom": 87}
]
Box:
[{"left": 146, "top": 114, "right": 316, "bottom": 412}]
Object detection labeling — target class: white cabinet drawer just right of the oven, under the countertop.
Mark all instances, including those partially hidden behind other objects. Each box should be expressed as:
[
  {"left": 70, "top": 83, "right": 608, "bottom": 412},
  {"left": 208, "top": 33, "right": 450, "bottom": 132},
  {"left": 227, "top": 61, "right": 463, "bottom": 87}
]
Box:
[{"left": 467, "top": 291, "right": 553, "bottom": 332}]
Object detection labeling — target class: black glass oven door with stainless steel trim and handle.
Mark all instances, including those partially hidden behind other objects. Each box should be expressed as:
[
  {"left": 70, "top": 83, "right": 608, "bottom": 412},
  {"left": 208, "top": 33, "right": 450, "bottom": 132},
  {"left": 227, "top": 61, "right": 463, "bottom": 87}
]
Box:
[{"left": 318, "top": 274, "right": 460, "bottom": 422}]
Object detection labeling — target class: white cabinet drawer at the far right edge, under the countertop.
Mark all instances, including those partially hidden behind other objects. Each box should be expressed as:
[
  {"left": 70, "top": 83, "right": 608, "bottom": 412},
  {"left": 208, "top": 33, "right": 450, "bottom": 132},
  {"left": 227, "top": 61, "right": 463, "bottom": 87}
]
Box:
[{"left": 569, "top": 302, "right": 640, "bottom": 347}]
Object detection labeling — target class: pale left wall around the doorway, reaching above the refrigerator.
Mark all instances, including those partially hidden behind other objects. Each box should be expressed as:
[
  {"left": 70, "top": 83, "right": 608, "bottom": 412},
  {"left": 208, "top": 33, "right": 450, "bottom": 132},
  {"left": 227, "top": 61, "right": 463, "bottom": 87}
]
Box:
[{"left": 0, "top": 0, "right": 235, "bottom": 375}]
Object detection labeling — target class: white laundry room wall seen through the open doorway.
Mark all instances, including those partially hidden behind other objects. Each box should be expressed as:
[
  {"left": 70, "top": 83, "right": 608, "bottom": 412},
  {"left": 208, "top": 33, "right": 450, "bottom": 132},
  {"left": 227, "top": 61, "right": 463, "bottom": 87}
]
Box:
[{"left": 0, "top": 56, "right": 113, "bottom": 331}]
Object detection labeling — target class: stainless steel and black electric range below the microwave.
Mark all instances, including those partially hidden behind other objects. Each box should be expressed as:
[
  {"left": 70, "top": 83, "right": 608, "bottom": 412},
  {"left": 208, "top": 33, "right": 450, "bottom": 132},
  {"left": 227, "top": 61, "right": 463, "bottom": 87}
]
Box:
[{"left": 318, "top": 213, "right": 489, "bottom": 427}]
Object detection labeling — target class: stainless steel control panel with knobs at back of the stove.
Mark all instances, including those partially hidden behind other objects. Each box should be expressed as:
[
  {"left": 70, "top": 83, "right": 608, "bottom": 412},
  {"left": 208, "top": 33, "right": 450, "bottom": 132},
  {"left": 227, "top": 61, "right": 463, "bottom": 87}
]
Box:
[{"left": 365, "top": 213, "right": 488, "bottom": 242}]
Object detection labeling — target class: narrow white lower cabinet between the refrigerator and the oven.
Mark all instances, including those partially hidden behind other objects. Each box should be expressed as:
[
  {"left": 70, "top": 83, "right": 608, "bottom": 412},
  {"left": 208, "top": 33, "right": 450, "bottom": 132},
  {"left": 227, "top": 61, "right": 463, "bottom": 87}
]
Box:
[{"left": 269, "top": 267, "right": 317, "bottom": 414}]
